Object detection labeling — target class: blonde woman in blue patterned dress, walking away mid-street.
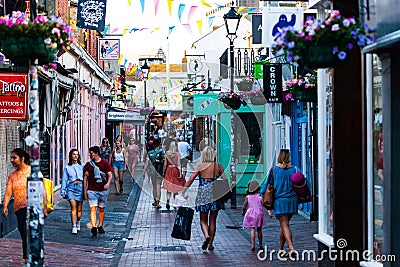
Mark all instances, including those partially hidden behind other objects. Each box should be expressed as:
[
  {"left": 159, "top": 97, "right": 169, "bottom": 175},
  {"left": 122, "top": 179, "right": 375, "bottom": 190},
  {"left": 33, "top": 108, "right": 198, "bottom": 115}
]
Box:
[{"left": 182, "top": 146, "right": 226, "bottom": 250}]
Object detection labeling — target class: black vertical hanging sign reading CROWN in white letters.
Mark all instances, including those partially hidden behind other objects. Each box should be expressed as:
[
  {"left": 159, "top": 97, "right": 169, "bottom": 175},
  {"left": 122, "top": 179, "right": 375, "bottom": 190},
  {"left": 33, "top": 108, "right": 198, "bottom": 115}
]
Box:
[{"left": 263, "top": 64, "right": 283, "bottom": 103}]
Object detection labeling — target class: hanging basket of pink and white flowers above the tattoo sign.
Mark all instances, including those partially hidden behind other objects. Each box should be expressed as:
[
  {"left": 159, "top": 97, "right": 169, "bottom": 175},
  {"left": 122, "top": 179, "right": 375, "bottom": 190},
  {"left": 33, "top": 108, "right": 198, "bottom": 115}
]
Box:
[{"left": 0, "top": 11, "right": 74, "bottom": 64}]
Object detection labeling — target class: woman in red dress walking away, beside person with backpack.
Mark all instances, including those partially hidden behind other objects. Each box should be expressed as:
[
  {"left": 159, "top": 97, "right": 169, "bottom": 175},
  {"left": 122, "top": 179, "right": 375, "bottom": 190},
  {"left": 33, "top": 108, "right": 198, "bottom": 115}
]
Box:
[{"left": 163, "top": 142, "right": 186, "bottom": 210}]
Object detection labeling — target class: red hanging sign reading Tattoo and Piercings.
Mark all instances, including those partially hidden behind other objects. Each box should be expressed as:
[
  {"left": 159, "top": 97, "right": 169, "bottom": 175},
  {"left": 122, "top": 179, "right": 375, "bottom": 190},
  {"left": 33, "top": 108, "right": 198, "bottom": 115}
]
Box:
[{"left": 0, "top": 73, "right": 28, "bottom": 121}]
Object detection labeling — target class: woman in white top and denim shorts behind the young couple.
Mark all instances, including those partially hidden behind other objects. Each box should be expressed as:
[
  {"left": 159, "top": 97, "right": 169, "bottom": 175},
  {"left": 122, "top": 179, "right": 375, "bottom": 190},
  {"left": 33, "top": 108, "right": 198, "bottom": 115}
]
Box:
[{"left": 110, "top": 141, "right": 126, "bottom": 196}]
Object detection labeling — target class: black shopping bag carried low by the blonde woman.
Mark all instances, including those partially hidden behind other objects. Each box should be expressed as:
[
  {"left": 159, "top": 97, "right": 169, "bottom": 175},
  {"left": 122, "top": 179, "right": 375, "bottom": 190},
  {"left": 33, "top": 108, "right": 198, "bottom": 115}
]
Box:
[{"left": 171, "top": 207, "right": 194, "bottom": 240}]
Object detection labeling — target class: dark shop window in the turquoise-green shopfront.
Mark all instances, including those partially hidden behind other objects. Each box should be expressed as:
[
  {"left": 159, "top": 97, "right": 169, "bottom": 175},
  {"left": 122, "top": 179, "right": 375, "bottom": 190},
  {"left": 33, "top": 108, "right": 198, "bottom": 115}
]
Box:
[{"left": 235, "top": 112, "right": 263, "bottom": 164}]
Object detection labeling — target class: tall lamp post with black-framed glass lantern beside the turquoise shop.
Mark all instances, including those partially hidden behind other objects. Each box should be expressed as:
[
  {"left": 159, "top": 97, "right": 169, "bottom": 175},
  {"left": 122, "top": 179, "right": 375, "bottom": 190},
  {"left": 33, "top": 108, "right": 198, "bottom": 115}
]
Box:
[{"left": 224, "top": 7, "right": 242, "bottom": 209}]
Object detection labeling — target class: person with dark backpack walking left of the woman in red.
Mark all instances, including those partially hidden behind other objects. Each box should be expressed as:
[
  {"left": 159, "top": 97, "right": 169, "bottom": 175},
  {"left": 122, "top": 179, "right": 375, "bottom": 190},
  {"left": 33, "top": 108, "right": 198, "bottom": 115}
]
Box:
[{"left": 142, "top": 139, "right": 165, "bottom": 209}]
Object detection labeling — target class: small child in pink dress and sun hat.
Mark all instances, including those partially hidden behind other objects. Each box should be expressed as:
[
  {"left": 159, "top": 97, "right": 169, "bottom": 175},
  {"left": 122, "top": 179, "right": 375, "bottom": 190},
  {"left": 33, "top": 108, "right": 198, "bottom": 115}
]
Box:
[{"left": 242, "top": 180, "right": 272, "bottom": 251}]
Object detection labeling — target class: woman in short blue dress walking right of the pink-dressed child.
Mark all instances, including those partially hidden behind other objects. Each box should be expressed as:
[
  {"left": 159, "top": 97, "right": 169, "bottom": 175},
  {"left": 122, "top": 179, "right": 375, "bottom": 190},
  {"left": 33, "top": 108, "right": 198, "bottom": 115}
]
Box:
[{"left": 260, "top": 149, "right": 298, "bottom": 253}]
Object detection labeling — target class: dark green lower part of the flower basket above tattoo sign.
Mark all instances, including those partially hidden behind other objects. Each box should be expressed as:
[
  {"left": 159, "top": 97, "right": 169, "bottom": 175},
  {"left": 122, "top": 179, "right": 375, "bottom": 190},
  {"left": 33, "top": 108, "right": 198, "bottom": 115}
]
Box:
[{"left": 2, "top": 35, "right": 57, "bottom": 65}]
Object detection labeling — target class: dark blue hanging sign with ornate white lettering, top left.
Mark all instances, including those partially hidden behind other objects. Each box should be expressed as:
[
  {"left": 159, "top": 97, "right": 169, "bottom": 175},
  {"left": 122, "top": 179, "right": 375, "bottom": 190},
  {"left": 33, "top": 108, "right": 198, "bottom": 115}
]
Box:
[{"left": 76, "top": 0, "right": 107, "bottom": 32}]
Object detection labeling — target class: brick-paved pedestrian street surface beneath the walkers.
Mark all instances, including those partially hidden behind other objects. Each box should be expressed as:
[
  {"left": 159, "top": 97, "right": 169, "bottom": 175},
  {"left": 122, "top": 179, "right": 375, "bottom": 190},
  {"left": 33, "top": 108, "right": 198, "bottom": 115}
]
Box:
[{"left": 0, "top": 162, "right": 317, "bottom": 266}]
